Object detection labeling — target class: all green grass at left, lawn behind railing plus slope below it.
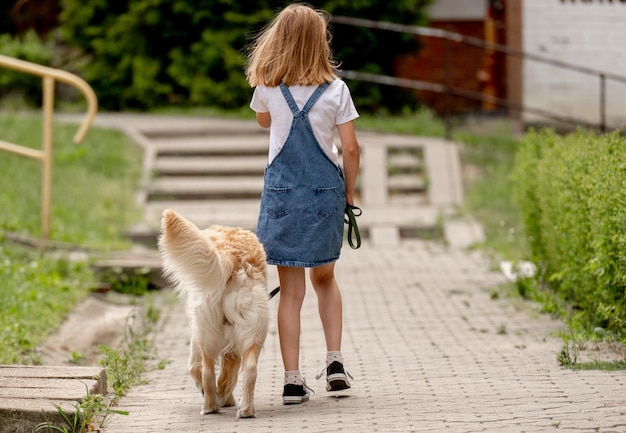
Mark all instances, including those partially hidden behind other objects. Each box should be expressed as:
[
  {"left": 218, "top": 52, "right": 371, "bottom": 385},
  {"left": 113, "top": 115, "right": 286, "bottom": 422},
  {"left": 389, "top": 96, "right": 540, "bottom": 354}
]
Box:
[{"left": 0, "top": 112, "right": 141, "bottom": 364}]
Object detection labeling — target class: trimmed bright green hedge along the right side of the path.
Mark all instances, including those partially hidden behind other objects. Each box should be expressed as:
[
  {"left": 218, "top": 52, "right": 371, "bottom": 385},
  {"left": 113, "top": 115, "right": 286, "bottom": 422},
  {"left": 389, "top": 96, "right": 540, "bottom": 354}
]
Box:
[{"left": 513, "top": 126, "right": 626, "bottom": 336}]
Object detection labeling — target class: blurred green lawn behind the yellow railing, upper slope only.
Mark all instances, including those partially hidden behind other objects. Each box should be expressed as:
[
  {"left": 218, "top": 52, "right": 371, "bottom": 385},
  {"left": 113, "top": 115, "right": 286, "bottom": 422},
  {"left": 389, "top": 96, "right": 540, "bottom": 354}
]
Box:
[{"left": 0, "top": 109, "right": 141, "bottom": 249}]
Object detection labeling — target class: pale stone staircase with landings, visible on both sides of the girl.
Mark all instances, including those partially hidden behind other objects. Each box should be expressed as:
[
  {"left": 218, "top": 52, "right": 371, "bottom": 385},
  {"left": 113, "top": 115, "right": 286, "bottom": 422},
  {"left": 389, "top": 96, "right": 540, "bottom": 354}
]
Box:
[{"left": 96, "top": 116, "right": 462, "bottom": 276}]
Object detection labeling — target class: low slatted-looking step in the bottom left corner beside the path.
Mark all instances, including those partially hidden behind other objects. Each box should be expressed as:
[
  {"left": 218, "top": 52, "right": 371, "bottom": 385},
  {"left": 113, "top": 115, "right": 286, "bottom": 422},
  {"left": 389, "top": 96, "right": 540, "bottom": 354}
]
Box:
[{"left": 0, "top": 365, "right": 107, "bottom": 433}]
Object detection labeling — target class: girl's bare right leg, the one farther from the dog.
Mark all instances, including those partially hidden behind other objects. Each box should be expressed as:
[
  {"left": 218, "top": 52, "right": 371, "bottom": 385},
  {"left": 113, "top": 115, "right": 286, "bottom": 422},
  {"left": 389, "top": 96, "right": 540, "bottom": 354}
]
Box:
[{"left": 308, "top": 262, "right": 343, "bottom": 352}]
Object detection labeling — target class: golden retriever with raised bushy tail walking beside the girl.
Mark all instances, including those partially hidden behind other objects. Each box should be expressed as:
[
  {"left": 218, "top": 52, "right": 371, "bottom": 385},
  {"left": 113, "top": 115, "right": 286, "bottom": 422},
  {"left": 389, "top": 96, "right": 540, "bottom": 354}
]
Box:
[{"left": 158, "top": 209, "right": 269, "bottom": 418}]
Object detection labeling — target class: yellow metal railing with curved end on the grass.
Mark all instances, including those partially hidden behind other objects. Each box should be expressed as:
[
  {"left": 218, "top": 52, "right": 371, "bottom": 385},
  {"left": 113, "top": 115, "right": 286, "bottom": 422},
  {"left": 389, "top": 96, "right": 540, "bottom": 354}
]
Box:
[{"left": 0, "top": 54, "right": 98, "bottom": 239}]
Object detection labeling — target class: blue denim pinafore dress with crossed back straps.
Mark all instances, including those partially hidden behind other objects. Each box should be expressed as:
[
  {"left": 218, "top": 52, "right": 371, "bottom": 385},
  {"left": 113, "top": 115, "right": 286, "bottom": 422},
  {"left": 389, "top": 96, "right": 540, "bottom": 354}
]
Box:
[{"left": 256, "top": 83, "right": 346, "bottom": 267}]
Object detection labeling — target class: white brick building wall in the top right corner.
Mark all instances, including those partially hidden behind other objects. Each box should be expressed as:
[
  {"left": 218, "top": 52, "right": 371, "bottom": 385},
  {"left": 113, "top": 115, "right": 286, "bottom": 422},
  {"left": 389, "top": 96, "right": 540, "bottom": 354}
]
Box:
[{"left": 521, "top": 0, "right": 626, "bottom": 127}]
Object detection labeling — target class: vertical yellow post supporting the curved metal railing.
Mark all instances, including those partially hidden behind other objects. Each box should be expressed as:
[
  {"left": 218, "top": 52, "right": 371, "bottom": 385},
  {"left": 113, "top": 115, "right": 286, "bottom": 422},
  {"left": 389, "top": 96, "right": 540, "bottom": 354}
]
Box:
[{"left": 41, "top": 76, "right": 54, "bottom": 240}]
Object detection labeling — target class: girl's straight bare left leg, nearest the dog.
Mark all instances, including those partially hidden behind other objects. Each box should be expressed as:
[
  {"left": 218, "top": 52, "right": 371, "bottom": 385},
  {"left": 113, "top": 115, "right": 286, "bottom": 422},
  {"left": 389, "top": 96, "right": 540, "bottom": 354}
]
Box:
[{"left": 278, "top": 266, "right": 306, "bottom": 371}]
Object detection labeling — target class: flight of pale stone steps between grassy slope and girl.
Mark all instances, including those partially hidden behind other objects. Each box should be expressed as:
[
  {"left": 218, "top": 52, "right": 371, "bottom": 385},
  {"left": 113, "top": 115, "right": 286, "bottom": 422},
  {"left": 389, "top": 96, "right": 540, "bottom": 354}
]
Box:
[{"left": 143, "top": 129, "right": 268, "bottom": 232}]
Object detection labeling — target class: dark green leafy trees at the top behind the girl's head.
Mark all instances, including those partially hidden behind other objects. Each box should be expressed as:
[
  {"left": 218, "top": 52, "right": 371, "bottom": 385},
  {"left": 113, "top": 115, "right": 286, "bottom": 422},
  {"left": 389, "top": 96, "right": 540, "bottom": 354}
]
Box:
[{"left": 61, "top": 0, "right": 432, "bottom": 112}]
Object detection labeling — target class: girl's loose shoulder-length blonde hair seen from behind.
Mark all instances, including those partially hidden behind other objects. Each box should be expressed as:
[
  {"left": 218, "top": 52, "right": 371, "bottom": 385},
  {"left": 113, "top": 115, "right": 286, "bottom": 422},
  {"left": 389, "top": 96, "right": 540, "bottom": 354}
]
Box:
[{"left": 246, "top": 3, "right": 337, "bottom": 87}]
